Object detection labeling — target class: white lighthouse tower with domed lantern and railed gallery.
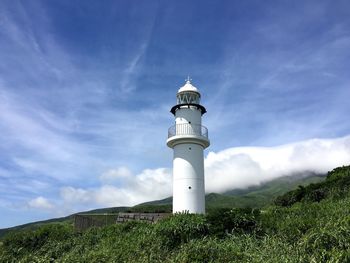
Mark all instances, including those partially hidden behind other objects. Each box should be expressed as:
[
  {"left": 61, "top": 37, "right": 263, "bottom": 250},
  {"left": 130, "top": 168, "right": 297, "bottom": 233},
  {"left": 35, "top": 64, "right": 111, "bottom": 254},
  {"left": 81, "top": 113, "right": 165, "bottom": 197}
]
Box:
[{"left": 167, "top": 78, "right": 210, "bottom": 214}]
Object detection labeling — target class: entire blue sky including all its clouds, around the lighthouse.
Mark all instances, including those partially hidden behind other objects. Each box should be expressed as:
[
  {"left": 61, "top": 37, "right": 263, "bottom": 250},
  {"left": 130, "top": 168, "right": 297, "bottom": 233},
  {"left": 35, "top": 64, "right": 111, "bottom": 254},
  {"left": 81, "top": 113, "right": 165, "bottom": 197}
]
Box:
[{"left": 0, "top": 0, "right": 350, "bottom": 228}]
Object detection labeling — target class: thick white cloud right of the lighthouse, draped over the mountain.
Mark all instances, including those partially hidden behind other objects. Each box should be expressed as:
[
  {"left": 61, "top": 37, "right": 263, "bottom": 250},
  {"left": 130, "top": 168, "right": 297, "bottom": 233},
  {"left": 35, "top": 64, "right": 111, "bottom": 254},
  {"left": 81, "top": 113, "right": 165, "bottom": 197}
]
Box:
[{"left": 205, "top": 136, "right": 350, "bottom": 192}]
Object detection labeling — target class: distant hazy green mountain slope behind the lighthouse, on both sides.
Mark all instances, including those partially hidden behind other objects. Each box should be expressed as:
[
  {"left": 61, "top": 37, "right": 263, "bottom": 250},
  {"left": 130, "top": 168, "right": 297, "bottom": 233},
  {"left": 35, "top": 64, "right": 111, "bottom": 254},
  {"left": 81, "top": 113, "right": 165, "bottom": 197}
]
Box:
[{"left": 0, "top": 173, "right": 326, "bottom": 238}]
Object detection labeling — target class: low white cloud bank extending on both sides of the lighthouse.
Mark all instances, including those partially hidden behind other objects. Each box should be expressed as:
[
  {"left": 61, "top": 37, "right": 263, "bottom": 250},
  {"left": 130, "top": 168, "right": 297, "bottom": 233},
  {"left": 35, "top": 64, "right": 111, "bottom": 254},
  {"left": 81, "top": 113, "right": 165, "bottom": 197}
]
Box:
[{"left": 61, "top": 136, "right": 350, "bottom": 207}]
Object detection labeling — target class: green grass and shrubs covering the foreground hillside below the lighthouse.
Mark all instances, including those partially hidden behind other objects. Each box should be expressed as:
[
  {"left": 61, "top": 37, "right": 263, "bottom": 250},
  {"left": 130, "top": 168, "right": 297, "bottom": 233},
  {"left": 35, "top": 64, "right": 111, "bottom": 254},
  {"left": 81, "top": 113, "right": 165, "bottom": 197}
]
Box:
[{"left": 0, "top": 166, "right": 350, "bottom": 262}]
